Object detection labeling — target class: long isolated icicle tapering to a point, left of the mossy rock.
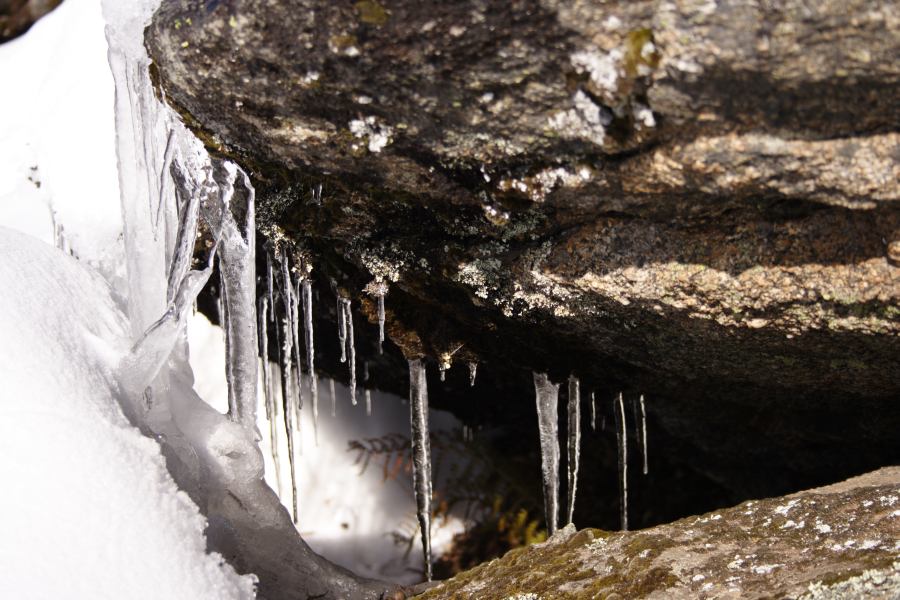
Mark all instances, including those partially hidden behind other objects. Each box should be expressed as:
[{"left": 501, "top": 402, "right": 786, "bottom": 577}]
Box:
[{"left": 409, "top": 359, "right": 431, "bottom": 581}]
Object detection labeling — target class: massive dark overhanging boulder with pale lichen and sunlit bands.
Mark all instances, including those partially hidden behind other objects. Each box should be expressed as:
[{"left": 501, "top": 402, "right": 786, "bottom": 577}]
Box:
[{"left": 146, "top": 0, "right": 900, "bottom": 548}]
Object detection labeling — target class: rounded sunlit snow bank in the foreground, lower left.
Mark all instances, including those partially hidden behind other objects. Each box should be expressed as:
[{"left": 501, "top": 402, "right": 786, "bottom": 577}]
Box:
[{"left": 0, "top": 227, "right": 253, "bottom": 600}]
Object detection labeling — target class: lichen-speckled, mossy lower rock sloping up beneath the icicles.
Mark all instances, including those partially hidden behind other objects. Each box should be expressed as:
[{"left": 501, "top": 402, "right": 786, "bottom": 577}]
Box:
[{"left": 421, "top": 467, "right": 900, "bottom": 600}]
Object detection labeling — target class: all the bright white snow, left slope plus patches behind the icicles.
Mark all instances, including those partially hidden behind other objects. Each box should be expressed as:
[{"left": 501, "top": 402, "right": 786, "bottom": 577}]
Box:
[{"left": 0, "top": 0, "right": 461, "bottom": 600}]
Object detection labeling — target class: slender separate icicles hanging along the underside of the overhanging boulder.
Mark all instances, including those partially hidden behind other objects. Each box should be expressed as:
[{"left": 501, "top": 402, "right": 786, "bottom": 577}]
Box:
[{"left": 246, "top": 247, "right": 648, "bottom": 580}]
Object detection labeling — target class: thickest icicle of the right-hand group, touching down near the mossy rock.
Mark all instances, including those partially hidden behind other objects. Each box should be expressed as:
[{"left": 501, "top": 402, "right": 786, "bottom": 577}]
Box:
[{"left": 534, "top": 373, "right": 559, "bottom": 535}]
